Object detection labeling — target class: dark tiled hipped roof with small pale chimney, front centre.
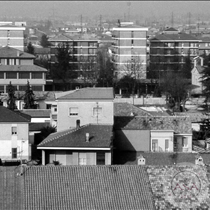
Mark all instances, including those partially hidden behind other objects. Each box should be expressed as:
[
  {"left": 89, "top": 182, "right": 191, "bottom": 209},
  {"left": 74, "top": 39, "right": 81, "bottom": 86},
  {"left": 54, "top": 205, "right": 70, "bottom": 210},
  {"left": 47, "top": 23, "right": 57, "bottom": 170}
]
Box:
[{"left": 38, "top": 124, "right": 113, "bottom": 149}]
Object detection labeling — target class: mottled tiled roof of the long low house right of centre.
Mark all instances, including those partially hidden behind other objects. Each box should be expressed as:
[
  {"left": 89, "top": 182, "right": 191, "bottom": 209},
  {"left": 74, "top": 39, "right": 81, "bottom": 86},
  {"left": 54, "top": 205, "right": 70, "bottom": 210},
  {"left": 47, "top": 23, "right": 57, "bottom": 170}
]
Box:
[{"left": 114, "top": 116, "right": 192, "bottom": 134}]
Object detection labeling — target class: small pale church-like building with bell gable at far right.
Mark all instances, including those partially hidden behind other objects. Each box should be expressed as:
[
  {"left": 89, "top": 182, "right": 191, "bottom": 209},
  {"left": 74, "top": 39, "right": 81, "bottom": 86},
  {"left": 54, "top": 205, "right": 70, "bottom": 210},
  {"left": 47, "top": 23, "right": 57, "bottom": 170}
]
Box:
[{"left": 191, "top": 56, "right": 204, "bottom": 94}]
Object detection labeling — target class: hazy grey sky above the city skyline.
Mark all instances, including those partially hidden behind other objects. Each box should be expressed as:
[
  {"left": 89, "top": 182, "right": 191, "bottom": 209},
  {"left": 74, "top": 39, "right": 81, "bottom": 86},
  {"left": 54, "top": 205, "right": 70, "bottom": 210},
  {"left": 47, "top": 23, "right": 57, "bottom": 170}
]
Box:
[{"left": 0, "top": 1, "right": 210, "bottom": 17}]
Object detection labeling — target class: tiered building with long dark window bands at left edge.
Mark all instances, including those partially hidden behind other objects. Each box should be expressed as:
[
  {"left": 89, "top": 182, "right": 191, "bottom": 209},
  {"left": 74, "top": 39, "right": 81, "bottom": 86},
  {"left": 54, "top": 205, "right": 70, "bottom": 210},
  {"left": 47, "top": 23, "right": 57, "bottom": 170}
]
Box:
[{"left": 0, "top": 47, "right": 47, "bottom": 92}]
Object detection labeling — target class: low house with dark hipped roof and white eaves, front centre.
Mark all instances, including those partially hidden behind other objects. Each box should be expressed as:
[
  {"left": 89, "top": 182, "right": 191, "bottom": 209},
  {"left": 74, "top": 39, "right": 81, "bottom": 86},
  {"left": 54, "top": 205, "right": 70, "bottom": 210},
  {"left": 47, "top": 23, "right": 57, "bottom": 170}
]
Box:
[{"left": 37, "top": 124, "right": 113, "bottom": 165}]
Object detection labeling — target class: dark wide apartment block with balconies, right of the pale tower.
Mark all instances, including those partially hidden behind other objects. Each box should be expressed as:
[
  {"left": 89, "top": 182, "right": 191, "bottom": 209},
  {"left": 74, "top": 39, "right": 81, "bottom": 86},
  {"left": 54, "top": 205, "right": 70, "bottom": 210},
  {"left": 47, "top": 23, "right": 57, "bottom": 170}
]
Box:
[{"left": 150, "top": 27, "right": 201, "bottom": 78}]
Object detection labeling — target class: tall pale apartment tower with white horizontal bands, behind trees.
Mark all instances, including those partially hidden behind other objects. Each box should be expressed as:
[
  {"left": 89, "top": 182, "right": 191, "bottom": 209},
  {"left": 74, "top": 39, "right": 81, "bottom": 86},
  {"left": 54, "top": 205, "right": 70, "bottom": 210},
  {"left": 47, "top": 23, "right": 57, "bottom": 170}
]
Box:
[{"left": 112, "top": 24, "right": 148, "bottom": 79}]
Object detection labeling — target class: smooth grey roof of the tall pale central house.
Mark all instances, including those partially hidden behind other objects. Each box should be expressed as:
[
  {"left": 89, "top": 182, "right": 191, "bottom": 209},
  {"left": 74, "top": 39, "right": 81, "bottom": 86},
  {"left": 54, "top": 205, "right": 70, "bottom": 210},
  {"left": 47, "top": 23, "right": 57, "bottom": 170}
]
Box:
[{"left": 58, "top": 88, "right": 114, "bottom": 100}]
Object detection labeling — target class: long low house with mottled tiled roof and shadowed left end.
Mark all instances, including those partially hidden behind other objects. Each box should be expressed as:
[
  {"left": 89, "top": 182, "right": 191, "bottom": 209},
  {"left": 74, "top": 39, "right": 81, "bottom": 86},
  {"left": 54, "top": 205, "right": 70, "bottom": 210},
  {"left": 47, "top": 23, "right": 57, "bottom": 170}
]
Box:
[{"left": 114, "top": 116, "right": 192, "bottom": 152}]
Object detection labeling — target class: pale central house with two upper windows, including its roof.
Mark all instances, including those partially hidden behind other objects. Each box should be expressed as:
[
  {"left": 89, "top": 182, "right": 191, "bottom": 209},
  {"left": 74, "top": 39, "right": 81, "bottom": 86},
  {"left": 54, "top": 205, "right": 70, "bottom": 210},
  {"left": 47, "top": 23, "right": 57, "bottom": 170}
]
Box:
[{"left": 57, "top": 88, "right": 114, "bottom": 131}]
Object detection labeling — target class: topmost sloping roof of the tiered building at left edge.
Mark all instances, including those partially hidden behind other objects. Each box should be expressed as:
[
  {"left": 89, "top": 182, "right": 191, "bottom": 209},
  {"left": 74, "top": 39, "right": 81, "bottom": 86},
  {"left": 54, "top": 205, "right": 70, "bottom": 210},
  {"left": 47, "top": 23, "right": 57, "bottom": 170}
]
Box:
[{"left": 0, "top": 46, "right": 35, "bottom": 59}]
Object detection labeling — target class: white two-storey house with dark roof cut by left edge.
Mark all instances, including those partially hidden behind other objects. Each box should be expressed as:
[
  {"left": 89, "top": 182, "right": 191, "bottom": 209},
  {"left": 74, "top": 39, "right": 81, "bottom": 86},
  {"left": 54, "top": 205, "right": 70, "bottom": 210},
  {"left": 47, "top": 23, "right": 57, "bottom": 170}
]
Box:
[{"left": 0, "top": 106, "right": 30, "bottom": 161}]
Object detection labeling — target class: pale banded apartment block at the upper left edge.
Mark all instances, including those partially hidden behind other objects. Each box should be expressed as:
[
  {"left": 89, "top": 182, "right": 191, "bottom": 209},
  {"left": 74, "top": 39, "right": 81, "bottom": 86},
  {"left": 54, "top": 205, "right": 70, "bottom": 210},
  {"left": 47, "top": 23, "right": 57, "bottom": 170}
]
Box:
[{"left": 0, "top": 25, "right": 25, "bottom": 51}]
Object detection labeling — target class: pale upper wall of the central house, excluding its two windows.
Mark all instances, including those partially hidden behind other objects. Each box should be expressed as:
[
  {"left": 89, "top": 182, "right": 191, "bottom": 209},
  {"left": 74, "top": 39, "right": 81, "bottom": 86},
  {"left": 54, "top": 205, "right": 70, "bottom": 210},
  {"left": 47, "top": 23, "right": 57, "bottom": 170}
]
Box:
[{"left": 57, "top": 100, "right": 114, "bottom": 131}]
